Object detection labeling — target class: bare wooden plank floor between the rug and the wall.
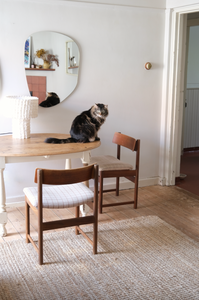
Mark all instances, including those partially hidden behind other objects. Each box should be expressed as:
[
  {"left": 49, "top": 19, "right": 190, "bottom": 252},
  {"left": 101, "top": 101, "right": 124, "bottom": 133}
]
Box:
[{"left": 0, "top": 186, "right": 199, "bottom": 243}]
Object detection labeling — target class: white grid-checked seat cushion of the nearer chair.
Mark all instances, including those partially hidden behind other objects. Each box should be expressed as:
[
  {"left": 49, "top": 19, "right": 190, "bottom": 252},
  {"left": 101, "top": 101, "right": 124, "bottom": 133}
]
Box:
[{"left": 23, "top": 183, "right": 94, "bottom": 208}]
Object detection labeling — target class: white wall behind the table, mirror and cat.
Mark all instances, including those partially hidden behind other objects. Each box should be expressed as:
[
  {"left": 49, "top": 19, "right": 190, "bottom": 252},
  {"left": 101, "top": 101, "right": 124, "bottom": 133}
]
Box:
[{"left": 0, "top": 0, "right": 165, "bottom": 201}]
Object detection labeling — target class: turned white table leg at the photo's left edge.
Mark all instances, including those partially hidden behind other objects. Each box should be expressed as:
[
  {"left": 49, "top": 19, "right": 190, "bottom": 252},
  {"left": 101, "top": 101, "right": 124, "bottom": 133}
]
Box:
[{"left": 0, "top": 168, "right": 7, "bottom": 236}]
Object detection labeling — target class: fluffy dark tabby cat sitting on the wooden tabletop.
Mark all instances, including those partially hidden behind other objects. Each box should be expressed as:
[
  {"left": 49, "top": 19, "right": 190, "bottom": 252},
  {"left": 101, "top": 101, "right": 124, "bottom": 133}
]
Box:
[{"left": 45, "top": 103, "right": 108, "bottom": 144}]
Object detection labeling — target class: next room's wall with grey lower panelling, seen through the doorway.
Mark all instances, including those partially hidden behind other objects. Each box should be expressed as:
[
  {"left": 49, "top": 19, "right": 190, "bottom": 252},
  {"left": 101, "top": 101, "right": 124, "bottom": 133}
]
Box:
[{"left": 182, "top": 12, "right": 199, "bottom": 151}]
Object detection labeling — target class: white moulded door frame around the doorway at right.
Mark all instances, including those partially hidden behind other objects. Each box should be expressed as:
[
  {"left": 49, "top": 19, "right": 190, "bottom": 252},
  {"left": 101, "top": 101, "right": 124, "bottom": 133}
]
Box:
[{"left": 159, "top": 4, "right": 199, "bottom": 185}]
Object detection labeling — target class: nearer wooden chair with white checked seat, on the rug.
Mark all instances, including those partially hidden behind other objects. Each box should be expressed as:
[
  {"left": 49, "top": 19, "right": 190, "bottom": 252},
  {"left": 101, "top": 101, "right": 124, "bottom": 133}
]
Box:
[{"left": 24, "top": 165, "right": 98, "bottom": 265}]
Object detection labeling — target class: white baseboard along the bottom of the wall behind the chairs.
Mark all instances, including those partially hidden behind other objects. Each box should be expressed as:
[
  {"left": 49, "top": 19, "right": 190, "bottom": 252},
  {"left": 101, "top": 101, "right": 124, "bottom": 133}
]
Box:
[{"left": 6, "top": 177, "right": 162, "bottom": 207}]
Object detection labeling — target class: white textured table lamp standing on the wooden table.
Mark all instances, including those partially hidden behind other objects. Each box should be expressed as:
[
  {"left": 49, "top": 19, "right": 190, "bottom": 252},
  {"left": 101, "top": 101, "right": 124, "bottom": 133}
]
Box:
[{"left": 3, "top": 96, "right": 39, "bottom": 139}]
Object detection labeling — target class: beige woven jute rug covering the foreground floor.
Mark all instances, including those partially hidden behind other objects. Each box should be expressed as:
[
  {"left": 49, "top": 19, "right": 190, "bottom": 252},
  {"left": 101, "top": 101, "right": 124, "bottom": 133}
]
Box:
[{"left": 0, "top": 216, "right": 199, "bottom": 300}]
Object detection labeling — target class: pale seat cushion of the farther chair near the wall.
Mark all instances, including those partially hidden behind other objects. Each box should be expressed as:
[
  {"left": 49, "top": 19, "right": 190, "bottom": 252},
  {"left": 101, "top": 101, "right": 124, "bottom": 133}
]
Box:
[{"left": 90, "top": 155, "right": 133, "bottom": 171}]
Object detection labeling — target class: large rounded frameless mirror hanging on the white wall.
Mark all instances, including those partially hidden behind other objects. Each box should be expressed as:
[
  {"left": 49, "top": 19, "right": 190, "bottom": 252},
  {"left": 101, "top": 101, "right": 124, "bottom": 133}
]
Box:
[{"left": 24, "top": 31, "right": 80, "bottom": 107}]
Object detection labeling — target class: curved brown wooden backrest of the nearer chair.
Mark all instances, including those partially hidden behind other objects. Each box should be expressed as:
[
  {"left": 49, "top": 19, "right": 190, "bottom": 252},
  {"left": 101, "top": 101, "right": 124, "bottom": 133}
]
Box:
[{"left": 34, "top": 165, "right": 98, "bottom": 185}]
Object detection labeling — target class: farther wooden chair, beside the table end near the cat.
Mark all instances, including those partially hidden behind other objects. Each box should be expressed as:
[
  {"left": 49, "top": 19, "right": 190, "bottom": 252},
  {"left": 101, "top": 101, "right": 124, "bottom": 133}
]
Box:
[{"left": 90, "top": 132, "right": 140, "bottom": 213}]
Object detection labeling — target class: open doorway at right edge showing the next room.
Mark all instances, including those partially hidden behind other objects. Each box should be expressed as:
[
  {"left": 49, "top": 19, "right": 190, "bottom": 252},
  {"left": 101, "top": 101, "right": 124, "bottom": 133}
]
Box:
[{"left": 176, "top": 12, "right": 199, "bottom": 196}]
